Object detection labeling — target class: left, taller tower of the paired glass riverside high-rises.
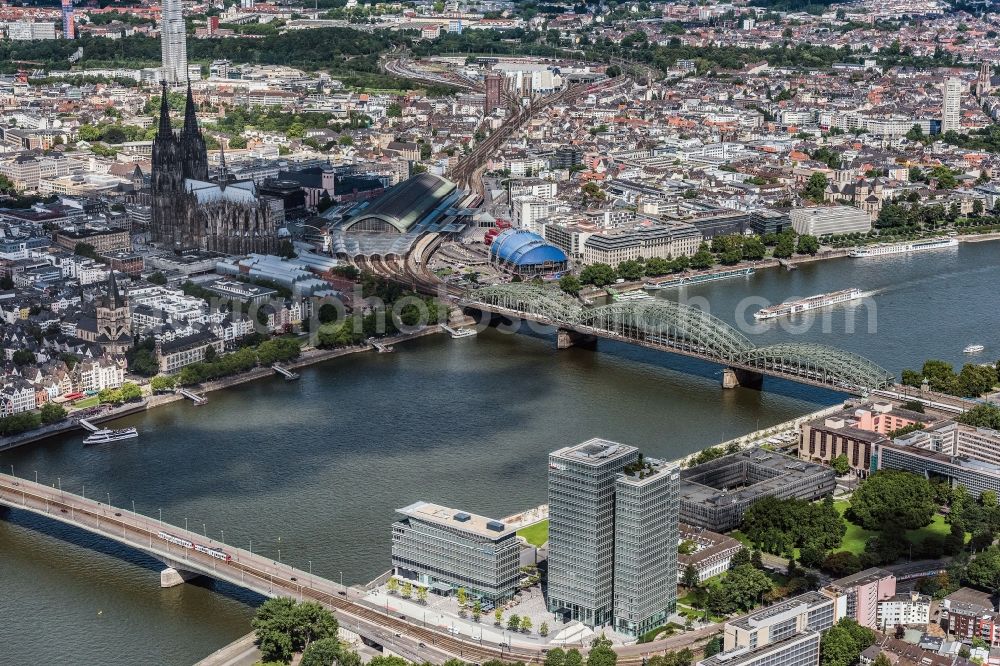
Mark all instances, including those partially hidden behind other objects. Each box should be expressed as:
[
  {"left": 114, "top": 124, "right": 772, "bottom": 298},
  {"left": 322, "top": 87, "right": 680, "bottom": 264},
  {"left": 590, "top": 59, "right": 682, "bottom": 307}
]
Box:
[{"left": 548, "top": 439, "right": 640, "bottom": 627}]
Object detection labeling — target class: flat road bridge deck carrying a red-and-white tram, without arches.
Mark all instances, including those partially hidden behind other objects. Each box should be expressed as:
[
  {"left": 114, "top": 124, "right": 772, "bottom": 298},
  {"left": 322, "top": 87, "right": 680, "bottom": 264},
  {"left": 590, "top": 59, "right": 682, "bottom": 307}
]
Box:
[{"left": 0, "top": 474, "right": 720, "bottom": 665}]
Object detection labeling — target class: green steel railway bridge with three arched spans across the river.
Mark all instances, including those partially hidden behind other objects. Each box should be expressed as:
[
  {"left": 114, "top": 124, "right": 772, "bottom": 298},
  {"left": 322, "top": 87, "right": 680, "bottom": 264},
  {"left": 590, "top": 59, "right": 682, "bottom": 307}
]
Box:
[{"left": 461, "top": 284, "right": 894, "bottom": 394}]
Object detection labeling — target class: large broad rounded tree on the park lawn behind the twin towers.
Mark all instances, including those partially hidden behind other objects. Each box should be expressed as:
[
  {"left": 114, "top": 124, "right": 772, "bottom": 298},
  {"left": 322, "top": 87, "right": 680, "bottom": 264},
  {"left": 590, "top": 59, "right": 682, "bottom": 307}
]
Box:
[{"left": 850, "top": 470, "right": 937, "bottom": 530}]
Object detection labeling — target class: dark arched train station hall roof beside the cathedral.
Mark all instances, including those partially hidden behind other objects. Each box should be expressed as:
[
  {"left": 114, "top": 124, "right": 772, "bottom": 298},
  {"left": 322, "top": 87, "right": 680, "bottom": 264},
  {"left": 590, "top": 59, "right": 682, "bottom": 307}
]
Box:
[{"left": 343, "top": 173, "right": 457, "bottom": 234}]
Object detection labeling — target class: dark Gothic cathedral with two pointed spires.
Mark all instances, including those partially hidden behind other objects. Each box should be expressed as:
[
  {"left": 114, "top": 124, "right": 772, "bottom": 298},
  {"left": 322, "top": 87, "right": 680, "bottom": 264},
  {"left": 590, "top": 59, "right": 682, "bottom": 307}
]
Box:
[{"left": 150, "top": 83, "right": 281, "bottom": 255}]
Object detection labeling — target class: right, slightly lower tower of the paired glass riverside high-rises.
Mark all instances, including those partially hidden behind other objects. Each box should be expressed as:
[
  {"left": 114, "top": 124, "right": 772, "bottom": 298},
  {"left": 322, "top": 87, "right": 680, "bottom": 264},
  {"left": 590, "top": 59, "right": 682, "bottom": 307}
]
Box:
[{"left": 614, "top": 454, "right": 680, "bottom": 636}]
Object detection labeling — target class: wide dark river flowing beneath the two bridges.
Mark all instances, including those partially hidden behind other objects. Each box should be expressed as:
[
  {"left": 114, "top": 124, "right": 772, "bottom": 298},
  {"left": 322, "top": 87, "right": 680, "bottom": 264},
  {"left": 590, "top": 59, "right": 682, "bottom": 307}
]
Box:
[{"left": 0, "top": 243, "right": 1000, "bottom": 666}]
